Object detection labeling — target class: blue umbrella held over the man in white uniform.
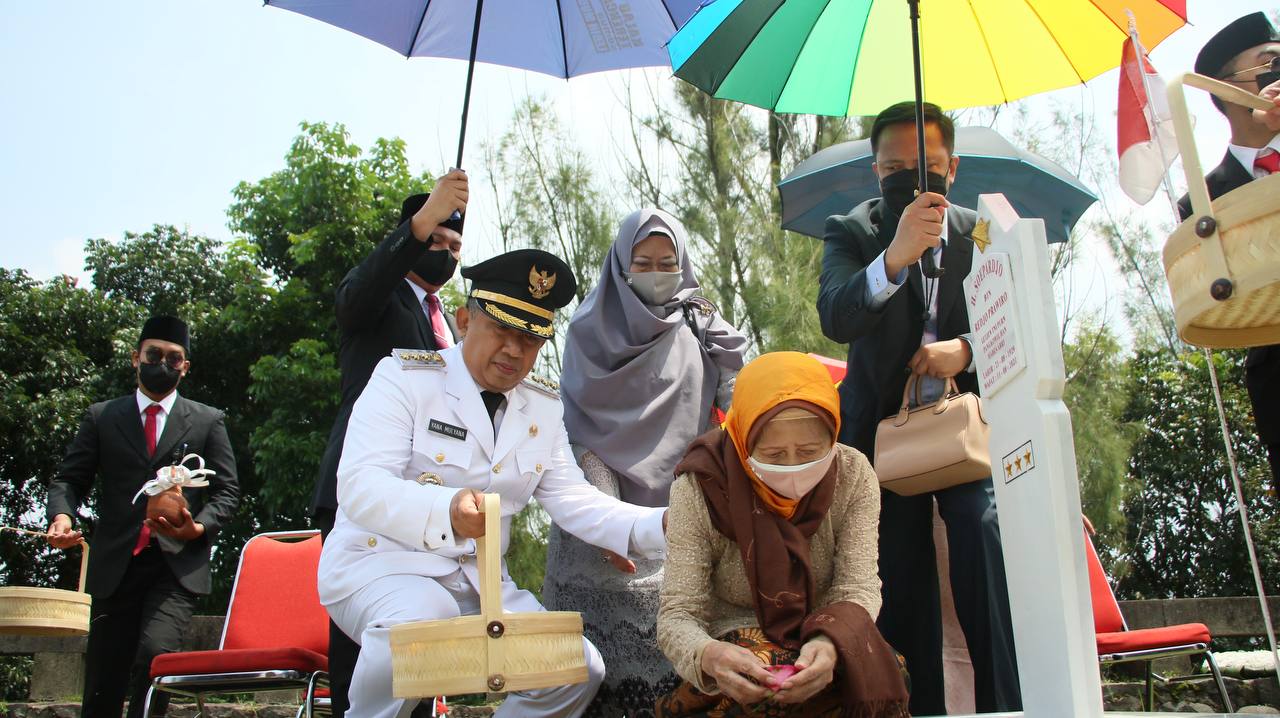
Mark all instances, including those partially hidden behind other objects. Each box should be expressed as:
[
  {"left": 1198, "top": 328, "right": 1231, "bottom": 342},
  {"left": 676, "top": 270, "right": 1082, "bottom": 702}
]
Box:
[{"left": 266, "top": 0, "right": 699, "bottom": 168}]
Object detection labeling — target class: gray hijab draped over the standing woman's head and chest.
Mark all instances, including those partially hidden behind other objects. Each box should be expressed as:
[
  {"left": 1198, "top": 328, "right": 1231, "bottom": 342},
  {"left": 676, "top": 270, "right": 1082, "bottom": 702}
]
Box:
[{"left": 561, "top": 209, "right": 746, "bottom": 506}]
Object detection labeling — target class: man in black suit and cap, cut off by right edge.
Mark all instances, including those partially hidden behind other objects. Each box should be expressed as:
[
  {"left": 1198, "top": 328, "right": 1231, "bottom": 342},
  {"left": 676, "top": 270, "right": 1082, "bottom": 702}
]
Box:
[{"left": 1178, "top": 13, "right": 1280, "bottom": 490}]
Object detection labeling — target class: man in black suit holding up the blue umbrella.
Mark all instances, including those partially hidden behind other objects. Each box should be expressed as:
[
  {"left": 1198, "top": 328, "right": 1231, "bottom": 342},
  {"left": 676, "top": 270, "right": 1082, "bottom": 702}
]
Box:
[{"left": 311, "top": 170, "right": 467, "bottom": 718}]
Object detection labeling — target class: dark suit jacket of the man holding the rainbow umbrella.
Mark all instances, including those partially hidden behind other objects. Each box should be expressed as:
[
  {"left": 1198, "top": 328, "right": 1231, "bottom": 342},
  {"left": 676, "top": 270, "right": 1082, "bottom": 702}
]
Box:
[{"left": 818, "top": 198, "right": 978, "bottom": 457}]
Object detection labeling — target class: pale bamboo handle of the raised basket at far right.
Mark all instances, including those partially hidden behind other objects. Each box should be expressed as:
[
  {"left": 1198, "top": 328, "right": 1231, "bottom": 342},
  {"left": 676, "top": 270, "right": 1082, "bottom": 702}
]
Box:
[{"left": 1167, "top": 73, "right": 1275, "bottom": 301}]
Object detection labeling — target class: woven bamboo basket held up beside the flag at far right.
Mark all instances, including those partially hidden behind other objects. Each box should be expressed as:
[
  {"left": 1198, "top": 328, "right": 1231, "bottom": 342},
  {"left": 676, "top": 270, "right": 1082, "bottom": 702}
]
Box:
[{"left": 1164, "top": 73, "right": 1280, "bottom": 349}]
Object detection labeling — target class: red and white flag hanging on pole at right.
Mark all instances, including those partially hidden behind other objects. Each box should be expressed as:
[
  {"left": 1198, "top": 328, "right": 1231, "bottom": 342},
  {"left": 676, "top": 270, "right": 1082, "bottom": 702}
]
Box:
[{"left": 1116, "top": 36, "right": 1178, "bottom": 205}]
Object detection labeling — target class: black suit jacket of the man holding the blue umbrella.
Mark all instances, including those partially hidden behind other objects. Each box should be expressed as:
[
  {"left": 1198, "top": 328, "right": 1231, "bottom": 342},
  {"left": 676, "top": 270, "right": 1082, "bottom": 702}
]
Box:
[{"left": 311, "top": 221, "right": 457, "bottom": 515}]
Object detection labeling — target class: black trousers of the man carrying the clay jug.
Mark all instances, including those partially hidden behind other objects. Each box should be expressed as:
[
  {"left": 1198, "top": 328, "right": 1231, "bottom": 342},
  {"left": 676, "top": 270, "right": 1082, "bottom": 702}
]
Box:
[{"left": 81, "top": 544, "right": 198, "bottom": 718}]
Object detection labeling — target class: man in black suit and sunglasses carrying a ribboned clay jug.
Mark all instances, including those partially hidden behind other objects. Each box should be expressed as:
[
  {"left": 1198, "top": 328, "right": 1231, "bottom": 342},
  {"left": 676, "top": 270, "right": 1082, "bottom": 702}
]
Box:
[{"left": 46, "top": 316, "right": 239, "bottom": 718}]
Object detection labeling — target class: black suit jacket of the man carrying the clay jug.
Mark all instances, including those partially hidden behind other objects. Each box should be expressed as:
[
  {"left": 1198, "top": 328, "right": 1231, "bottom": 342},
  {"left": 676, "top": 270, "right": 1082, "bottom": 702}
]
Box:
[{"left": 46, "top": 394, "right": 239, "bottom": 598}]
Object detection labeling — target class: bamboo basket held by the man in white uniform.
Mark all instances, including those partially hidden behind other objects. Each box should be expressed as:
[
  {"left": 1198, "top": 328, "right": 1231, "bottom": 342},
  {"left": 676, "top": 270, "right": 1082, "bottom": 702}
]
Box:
[{"left": 390, "top": 494, "right": 586, "bottom": 698}]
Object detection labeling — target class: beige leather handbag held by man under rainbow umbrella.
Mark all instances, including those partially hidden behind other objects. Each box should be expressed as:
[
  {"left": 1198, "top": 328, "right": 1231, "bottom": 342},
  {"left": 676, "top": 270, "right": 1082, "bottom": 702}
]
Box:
[{"left": 874, "top": 374, "right": 991, "bottom": 497}]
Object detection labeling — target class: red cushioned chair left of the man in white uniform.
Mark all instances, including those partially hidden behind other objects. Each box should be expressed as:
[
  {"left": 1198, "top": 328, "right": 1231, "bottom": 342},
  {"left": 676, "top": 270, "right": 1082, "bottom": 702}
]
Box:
[{"left": 142, "top": 531, "right": 329, "bottom": 718}]
